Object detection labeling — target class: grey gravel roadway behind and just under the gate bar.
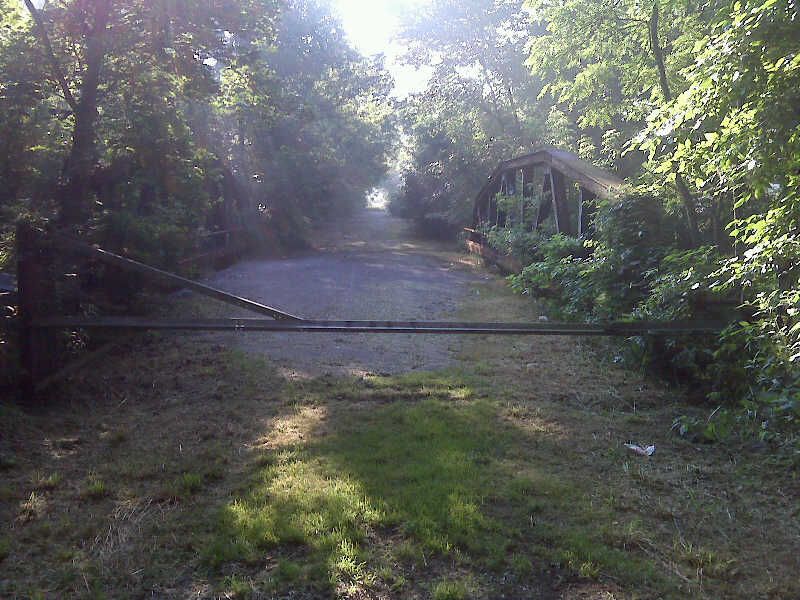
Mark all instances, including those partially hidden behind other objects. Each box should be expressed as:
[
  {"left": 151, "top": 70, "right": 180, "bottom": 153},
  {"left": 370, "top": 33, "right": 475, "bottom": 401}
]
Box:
[{"left": 203, "top": 210, "right": 487, "bottom": 376}]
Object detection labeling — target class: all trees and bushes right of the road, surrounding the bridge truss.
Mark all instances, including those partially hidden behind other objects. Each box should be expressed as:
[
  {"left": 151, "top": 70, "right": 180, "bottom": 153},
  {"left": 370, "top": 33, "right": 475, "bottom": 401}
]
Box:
[{"left": 392, "top": 0, "right": 800, "bottom": 446}]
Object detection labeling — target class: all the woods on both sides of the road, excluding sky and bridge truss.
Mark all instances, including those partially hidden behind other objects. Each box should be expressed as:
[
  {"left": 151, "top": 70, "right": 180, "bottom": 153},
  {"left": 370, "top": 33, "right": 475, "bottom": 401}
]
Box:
[{"left": 0, "top": 0, "right": 800, "bottom": 440}]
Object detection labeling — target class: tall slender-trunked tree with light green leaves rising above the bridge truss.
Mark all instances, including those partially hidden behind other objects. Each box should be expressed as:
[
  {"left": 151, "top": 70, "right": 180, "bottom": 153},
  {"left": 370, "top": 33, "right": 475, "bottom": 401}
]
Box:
[{"left": 527, "top": 0, "right": 716, "bottom": 245}]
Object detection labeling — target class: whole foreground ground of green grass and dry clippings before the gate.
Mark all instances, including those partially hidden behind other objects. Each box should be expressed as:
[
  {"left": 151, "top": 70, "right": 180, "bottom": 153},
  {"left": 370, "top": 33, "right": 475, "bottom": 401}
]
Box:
[{"left": 0, "top": 282, "right": 800, "bottom": 600}]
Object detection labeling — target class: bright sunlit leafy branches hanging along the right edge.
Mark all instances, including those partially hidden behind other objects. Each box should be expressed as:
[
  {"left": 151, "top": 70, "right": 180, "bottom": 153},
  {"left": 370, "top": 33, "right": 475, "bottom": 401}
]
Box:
[{"left": 637, "top": 0, "right": 800, "bottom": 440}]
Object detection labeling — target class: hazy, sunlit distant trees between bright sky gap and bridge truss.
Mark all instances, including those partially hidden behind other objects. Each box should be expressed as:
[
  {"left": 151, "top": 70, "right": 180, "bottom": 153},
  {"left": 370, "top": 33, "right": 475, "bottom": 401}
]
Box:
[{"left": 392, "top": 0, "right": 545, "bottom": 235}]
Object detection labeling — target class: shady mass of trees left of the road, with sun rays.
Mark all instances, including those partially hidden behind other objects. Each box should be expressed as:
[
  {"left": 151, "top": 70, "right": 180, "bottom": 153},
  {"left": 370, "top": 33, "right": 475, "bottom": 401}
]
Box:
[{"left": 0, "top": 0, "right": 391, "bottom": 267}]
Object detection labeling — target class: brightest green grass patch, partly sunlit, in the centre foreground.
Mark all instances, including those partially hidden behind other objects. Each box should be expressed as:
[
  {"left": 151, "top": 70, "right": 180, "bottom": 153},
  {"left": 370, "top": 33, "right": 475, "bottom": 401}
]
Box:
[{"left": 208, "top": 399, "right": 507, "bottom": 590}]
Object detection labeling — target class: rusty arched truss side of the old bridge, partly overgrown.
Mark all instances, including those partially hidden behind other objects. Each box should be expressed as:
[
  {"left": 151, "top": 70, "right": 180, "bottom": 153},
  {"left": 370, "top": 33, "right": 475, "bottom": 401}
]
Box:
[{"left": 467, "top": 147, "right": 625, "bottom": 240}]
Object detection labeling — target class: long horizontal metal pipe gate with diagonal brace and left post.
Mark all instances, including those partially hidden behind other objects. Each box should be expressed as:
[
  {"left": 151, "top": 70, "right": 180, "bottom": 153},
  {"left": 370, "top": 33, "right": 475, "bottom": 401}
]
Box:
[{"left": 16, "top": 223, "right": 725, "bottom": 400}]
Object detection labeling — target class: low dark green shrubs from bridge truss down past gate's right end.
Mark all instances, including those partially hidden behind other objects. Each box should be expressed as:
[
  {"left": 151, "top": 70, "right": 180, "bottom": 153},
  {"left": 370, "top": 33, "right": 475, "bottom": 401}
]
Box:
[{"left": 500, "top": 193, "right": 800, "bottom": 443}]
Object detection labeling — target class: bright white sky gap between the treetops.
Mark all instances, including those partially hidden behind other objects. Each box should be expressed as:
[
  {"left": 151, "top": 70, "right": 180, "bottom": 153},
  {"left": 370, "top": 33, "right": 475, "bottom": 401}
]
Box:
[{"left": 332, "top": 0, "right": 432, "bottom": 98}]
